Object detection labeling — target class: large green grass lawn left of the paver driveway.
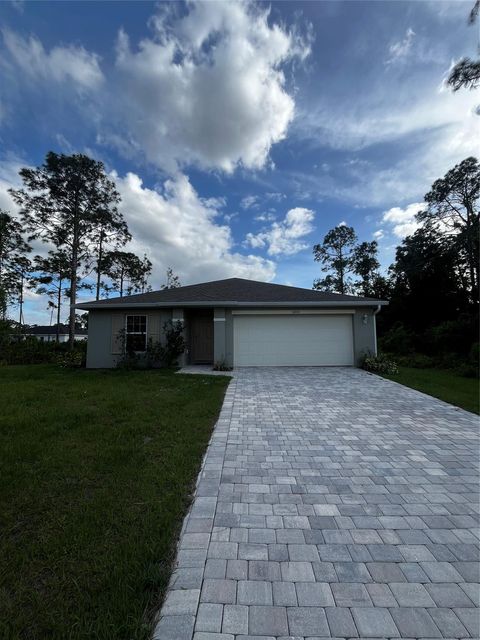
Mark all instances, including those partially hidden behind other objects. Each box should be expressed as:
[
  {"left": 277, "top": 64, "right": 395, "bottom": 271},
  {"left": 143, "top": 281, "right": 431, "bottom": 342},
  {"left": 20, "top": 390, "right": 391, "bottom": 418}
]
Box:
[{"left": 0, "top": 365, "right": 229, "bottom": 640}]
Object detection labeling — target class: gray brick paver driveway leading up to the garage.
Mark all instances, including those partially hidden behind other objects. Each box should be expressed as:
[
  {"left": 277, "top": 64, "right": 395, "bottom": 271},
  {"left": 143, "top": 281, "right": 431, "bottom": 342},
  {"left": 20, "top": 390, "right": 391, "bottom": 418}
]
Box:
[{"left": 155, "top": 368, "right": 480, "bottom": 640}]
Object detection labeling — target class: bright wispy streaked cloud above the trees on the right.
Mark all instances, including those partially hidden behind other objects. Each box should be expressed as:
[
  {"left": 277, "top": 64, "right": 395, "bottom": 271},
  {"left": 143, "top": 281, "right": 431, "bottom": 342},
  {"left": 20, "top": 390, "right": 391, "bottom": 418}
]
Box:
[{"left": 288, "top": 86, "right": 479, "bottom": 208}]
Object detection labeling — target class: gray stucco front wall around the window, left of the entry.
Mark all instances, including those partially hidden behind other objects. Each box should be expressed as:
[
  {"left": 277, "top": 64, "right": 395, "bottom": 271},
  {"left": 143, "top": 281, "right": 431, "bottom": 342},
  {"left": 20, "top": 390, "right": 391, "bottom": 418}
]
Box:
[{"left": 87, "top": 309, "right": 172, "bottom": 369}]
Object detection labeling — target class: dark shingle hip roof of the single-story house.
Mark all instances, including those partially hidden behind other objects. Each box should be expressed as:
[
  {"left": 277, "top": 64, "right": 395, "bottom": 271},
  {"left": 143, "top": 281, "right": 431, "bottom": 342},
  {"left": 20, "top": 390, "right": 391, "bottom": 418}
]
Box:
[{"left": 77, "top": 278, "right": 386, "bottom": 309}]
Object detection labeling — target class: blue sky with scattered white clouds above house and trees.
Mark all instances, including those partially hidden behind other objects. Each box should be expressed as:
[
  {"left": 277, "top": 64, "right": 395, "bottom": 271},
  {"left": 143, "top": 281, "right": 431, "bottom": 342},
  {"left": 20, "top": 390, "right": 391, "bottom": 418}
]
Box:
[{"left": 0, "top": 0, "right": 479, "bottom": 323}]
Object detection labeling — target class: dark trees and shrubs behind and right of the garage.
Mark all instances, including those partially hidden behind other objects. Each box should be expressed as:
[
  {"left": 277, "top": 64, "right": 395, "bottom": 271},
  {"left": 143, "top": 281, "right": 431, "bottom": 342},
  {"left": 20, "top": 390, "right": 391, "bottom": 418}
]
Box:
[{"left": 313, "top": 157, "right": 480, "bottom": 370}]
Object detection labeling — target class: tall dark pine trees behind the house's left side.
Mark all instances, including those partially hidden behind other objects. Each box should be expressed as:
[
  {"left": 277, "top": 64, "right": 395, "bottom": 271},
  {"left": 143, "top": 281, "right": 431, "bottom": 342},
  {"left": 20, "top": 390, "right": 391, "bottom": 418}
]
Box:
[{"left": 0, "top": 151, "right": 180, "bottom": 346}]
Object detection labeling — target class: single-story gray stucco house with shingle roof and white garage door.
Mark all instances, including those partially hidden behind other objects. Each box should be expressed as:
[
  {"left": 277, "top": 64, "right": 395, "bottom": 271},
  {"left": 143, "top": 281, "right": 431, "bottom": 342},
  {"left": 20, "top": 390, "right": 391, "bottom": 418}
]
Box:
[{"left": 77, "top": 278, "right": 388, "bottom": 368}]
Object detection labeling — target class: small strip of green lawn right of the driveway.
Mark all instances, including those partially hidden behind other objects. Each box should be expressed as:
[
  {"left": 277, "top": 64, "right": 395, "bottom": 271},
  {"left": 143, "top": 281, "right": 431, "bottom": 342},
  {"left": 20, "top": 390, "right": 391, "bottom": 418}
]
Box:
[{"left": 383, "top": 367, "right": 480, "bottom": 413}]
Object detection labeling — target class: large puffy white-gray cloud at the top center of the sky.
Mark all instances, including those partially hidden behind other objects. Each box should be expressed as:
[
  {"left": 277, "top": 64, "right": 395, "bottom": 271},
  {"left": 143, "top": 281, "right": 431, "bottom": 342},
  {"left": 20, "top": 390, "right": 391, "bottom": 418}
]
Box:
[{"left": 108, "top": 2, "right": 309, "bottom": 172}]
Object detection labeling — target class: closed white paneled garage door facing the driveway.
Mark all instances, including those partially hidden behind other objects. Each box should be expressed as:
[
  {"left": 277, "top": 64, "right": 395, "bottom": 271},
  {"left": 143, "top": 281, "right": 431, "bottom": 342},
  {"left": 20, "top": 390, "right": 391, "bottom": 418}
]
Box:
[{"left": 233, "top": 315, "right": 353, "bottom": 367}]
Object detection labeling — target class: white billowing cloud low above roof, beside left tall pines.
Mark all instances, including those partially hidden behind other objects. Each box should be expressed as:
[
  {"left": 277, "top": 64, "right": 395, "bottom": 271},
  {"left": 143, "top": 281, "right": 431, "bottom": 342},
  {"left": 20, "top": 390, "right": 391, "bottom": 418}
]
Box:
[{"left": 113, "top": 173, "right": 275, "bottom": 288}]
